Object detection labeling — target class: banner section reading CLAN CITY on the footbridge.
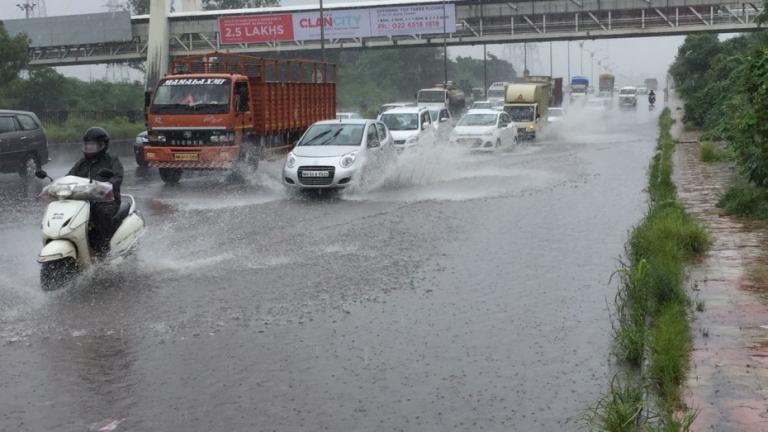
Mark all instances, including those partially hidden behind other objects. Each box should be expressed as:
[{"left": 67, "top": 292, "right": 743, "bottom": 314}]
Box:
[{"left": 293, "top": 9, "right": 371, "bottom": 41}]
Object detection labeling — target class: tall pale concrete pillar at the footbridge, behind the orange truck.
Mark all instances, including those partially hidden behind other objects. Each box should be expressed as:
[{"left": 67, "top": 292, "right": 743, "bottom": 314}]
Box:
[{"left": 145, "top": 0, "right": 171, "bottom": 91}]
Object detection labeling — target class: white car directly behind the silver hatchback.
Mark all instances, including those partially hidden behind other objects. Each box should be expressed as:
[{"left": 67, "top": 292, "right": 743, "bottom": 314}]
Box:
[{"left": 379, "top": 107, "right": 437, "bottom": 152}]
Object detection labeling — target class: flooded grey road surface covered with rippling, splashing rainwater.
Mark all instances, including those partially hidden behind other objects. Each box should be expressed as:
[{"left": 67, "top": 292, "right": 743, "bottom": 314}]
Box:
[{"left": 0, "top": 105, "right": 658, "bottom": 431}]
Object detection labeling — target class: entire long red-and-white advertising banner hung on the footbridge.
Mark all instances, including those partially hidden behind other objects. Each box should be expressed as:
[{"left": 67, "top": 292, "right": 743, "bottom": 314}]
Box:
[{"left": 219, "top": 4, "right": 456, "bottom": 44}]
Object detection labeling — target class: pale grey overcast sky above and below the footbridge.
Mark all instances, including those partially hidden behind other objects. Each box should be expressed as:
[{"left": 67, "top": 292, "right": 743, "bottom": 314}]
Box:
[{"left": 0, "top": 0, "right": 683, "bottom": 84}]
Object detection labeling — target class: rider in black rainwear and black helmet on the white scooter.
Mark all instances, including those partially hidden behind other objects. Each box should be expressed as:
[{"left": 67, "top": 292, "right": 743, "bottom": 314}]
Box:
[{"left": 67, "top": 127, "right": 123, "bottom": 256}]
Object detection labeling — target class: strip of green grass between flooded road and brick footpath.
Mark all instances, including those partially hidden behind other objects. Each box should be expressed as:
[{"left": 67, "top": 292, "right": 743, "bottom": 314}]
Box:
[{"left": 587, "top": 108, "right": 709, "bottom": 432}]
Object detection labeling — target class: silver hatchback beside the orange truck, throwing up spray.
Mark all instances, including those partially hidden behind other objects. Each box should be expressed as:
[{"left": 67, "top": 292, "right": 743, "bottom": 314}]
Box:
[{"left": 283, "top": 119, "right": 395, "bottom": 189}]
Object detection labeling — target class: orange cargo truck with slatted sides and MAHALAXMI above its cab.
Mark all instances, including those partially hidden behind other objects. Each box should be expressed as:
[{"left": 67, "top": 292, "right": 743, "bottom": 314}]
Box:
[{"left": 144, "top": 52, "right": 336, "bottom": 183}]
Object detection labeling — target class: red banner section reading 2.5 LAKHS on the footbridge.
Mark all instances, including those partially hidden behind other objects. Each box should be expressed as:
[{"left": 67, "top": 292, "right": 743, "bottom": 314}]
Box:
[{"left": 219, "top": 14, "right": 293, "bottom": 44}]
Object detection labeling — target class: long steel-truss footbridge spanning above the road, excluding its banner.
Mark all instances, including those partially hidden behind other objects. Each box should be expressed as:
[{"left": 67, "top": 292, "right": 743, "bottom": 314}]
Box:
[{"left": 6, "top": 0, "right": 762, "bottom": 66}]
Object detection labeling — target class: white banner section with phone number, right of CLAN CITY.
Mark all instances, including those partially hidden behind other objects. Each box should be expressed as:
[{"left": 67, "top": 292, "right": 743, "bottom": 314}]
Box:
[{"left": 371, "top": 4, "right": 456, "bottom": 36}]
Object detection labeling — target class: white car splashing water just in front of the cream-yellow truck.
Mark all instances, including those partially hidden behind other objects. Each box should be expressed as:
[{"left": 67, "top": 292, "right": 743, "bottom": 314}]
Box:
[{"left": 451, "top": 109, "right": 517, "bottom": 151}]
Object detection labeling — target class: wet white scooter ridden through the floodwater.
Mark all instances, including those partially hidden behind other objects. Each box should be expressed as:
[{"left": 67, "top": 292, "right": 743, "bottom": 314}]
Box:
[{"left": 35, "top": 170, "right": 144, "bottom": 291}]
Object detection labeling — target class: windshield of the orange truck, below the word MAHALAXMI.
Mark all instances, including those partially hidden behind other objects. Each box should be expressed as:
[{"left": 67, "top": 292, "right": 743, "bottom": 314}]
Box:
[{"left": 150, "top": 78, "right": 230, "bottom": 114}]
